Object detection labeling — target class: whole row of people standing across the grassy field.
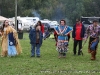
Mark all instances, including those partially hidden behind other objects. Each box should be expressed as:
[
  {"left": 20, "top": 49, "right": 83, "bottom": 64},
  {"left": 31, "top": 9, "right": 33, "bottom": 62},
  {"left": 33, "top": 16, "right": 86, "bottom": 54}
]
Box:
[{"left": 0, "top": 19, "right": 100, "bottom": 60}]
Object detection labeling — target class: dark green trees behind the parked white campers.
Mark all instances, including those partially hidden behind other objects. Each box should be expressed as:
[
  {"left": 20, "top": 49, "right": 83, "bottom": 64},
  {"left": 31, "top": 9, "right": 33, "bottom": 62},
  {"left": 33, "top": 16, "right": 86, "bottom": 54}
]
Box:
[{"left": 0, "top": 0, "right": 100, "bottom": 23}]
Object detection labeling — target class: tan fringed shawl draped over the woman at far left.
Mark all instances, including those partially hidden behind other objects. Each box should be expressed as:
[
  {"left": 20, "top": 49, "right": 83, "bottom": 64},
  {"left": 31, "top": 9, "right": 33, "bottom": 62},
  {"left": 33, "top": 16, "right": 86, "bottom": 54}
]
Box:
[{"left": 1, "top": 26, "right": 22, "bottom": 55}]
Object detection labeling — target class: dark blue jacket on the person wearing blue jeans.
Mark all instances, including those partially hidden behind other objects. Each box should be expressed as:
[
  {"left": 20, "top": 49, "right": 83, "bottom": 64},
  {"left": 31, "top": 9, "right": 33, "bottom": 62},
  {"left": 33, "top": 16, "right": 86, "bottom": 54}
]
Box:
[{"left": 29, "top": 29, "right": 43, "bottom": 45}]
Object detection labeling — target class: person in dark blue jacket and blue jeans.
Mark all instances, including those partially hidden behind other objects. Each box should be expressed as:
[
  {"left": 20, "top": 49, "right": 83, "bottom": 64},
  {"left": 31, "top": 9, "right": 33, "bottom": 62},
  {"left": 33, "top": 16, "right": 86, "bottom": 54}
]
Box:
[{"left": 29, "top": 25, "right": 43, "bottom": 57}]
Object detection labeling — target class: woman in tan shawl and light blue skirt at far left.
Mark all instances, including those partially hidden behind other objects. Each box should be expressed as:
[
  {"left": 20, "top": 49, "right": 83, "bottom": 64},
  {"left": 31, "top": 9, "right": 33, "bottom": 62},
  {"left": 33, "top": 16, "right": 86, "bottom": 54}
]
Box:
[{"left": 0, "top": 20, "right": 22, "bottom": 57}]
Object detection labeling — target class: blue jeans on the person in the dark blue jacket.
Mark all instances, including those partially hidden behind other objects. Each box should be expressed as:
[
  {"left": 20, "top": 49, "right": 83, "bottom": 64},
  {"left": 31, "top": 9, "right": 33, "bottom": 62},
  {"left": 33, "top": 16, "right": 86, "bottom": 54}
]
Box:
[{"left": 31, "top": 44, "right": 41, "bottom": 56}]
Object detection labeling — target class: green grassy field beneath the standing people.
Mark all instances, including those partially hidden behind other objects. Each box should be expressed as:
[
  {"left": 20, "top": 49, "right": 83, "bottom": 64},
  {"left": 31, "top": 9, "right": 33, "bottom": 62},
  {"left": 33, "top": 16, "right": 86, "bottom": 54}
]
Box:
[{"left": 0, "top": 33, "right": 100, "bottom": 75}]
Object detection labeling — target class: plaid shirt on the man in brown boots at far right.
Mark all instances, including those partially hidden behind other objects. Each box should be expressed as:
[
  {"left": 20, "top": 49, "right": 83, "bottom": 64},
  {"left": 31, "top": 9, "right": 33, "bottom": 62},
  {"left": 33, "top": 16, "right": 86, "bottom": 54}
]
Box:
[{"left": 85, "top": 24, "right": 100, "bottom": 38}]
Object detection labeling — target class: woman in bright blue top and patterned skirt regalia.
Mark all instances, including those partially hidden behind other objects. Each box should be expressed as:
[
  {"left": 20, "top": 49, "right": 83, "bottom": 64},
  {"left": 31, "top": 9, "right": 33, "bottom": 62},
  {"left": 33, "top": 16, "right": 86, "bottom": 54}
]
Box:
[{"left": 55, "top": 20, "right": 72, "bottom": 58}]
